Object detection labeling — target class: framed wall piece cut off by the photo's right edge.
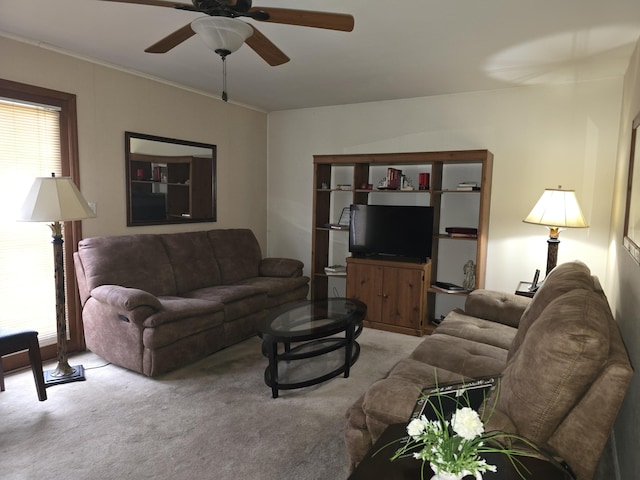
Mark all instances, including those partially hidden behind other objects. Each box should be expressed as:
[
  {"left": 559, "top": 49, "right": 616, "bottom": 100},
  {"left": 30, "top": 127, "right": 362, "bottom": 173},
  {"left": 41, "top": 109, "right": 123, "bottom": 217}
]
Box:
[{"left": 623, "top": 114, "right": 640, "bottom": 264}]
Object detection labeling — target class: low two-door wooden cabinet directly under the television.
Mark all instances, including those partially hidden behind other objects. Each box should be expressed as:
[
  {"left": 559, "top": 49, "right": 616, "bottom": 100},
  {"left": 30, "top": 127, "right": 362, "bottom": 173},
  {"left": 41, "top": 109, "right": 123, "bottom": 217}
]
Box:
[{"left": 347, "top": 258, "right": 431, "bottom": 336}]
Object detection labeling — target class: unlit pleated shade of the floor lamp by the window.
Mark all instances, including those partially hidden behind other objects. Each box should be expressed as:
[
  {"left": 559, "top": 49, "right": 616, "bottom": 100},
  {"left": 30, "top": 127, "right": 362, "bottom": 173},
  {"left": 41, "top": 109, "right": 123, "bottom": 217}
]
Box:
[{"left": 19, "top": 176, "right": 96, "bottom": 222}]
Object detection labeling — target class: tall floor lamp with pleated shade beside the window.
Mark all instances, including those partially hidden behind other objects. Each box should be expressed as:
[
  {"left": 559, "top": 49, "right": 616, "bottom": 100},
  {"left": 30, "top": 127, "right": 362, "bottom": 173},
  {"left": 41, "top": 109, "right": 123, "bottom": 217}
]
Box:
[{"left": 19, "top": 173, "right": 96, "bottom": 385}]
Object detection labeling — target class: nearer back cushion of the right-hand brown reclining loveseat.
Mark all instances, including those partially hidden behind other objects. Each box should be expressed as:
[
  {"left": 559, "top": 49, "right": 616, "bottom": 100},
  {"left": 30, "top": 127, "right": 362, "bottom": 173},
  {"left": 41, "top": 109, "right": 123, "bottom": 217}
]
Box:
[{"left": 497, "top": 289, "right": 610, "bottom": 448}]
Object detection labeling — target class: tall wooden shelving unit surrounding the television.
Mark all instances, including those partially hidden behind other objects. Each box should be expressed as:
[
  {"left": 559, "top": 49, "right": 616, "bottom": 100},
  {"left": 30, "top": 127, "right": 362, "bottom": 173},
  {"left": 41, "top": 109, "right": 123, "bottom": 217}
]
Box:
[{"left": 311, "top": 150, "right": 493, "bottom": 328}]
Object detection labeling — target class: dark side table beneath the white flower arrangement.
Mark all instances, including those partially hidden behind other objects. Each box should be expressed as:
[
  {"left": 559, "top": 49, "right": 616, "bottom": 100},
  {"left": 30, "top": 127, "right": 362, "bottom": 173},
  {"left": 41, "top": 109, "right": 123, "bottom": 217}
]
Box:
[{"left": 348, "top": 423, "right": 574, "bottom": 480}]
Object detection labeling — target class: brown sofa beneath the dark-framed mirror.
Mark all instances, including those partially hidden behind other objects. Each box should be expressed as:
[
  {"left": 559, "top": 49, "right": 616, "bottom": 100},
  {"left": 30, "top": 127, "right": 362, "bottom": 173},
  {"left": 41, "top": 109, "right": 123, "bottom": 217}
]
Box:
[{"left": 74, "top": 229, "right": 309, "bottom": 376}]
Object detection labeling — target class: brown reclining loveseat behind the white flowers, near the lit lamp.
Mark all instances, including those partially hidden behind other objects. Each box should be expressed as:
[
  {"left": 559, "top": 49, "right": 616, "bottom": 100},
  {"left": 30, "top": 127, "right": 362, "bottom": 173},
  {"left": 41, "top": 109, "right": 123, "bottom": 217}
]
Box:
[{"left": 345, "top": 262, "right": 633, "bottom": 480}]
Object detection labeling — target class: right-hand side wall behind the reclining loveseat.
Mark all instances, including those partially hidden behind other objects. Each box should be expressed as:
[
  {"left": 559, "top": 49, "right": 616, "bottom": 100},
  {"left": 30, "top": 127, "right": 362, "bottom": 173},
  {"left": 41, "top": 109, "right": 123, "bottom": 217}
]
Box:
[{"left": 607, "top": 38, "right": 640, "bottom": 479}]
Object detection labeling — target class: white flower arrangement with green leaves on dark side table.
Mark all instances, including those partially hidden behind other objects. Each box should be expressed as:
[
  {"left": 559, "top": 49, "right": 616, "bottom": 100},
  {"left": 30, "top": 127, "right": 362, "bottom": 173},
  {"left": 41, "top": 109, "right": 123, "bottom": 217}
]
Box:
[{"left": 391, "top": 378, "right": 535, "bottom": 480}]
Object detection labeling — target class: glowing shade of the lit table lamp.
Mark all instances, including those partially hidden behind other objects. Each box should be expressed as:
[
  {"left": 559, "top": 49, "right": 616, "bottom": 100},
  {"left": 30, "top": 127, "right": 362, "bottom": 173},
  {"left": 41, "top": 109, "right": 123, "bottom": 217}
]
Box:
[{"left": 523, "top": 188, "right": 588, "bottom": 228}]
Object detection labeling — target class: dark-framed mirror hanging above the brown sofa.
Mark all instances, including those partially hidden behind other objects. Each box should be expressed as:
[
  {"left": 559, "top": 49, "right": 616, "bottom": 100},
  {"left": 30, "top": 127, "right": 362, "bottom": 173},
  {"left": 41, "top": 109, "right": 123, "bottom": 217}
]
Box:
[{"left": 124, "top": 132, "right": 216, "bottom": 227}]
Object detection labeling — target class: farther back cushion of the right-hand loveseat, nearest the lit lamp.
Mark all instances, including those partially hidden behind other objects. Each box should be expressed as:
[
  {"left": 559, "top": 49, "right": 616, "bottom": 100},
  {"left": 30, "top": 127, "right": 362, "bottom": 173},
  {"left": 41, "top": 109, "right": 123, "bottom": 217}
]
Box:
[{"left": 507, "top": 261, "right": 594, "bottom": 360}]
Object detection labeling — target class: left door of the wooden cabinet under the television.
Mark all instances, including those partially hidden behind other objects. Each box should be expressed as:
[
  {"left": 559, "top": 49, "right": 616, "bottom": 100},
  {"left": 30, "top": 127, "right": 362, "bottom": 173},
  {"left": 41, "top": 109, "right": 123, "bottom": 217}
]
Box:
[{"left": 347, "top": 263, "right": 383, "bottom": 322}]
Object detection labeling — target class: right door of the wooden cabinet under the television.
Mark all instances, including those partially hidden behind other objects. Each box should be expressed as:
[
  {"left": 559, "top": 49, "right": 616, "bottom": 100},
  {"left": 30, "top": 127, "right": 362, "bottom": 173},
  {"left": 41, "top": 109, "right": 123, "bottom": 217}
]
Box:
[{"left": 381, "top": 267, "right": 423, "bottom": 329}]
